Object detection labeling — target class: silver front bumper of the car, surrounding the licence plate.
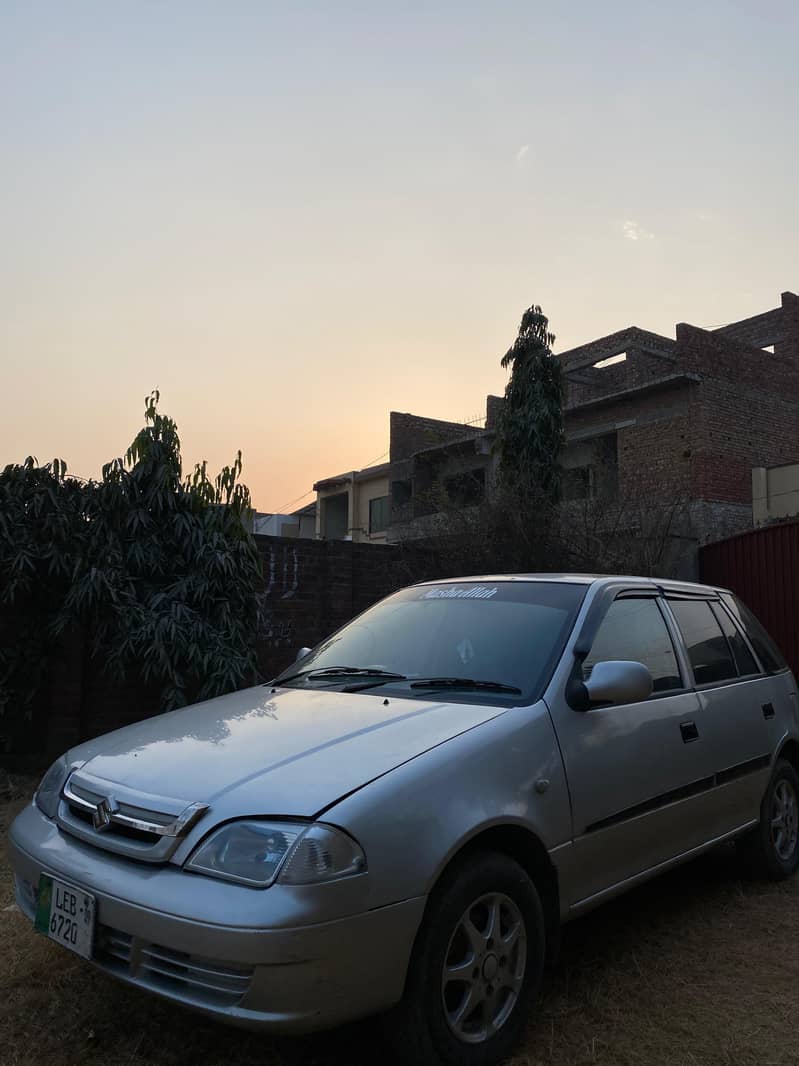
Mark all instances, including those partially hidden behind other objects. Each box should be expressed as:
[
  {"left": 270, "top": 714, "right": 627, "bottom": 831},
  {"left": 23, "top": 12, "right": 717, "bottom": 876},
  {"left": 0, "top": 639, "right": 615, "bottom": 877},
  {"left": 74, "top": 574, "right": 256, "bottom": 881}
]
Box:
[{"left": 9, "top": 807, "right": 425, "bottom": 1033}]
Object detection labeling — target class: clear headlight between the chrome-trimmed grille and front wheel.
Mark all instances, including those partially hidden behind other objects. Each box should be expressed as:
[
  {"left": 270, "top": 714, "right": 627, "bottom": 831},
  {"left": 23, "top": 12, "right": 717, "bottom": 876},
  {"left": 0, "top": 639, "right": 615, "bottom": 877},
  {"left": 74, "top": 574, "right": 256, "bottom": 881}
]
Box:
[{"left": 186, "top": 821, "right": 366, "bottom": 888}]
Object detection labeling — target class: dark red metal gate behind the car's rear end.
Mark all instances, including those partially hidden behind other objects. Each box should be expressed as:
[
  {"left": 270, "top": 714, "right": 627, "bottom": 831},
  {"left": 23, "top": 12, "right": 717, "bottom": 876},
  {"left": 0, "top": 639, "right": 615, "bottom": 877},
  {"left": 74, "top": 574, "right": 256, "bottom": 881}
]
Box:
[{"left": 699, "top": 521, "right": 799, "bottom": 677}]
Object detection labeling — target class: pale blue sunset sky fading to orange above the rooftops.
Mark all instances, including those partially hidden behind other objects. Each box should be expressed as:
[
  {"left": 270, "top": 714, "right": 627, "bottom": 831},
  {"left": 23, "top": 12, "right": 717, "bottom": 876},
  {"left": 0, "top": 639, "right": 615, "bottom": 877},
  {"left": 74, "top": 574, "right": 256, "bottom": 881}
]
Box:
[{"left": 0, "top": 0, "right": 799, "bottom": 511}]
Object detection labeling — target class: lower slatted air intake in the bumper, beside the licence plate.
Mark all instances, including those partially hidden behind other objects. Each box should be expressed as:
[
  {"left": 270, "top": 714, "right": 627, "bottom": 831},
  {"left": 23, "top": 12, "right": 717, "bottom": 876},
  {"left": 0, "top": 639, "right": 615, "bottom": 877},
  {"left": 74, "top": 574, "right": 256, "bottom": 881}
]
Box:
[{"left": 94, "top": 925, "right": 252, "bottom": 1007}]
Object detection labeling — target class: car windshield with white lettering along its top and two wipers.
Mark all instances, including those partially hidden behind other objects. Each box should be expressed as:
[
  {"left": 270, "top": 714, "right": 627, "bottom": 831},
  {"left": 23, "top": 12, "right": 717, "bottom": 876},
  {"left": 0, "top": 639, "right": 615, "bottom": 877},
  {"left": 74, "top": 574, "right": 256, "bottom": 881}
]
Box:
[{"left": 276, "top": 581, "right": 585, "bottom": 704}]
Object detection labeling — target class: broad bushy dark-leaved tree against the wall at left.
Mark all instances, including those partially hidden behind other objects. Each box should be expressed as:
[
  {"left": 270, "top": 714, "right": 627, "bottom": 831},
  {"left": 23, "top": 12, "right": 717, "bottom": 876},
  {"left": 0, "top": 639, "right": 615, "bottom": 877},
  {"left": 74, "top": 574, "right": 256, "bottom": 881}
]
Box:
[{"left": 0, "top": 392, "right": 261, "bottom": 754}]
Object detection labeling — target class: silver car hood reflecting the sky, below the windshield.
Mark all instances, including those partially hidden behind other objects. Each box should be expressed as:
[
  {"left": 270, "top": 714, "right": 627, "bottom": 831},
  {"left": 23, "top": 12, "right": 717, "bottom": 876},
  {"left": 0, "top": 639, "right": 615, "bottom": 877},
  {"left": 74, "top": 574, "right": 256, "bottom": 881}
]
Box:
[{"left": 70, "top": 685, "right": 503, "bottom": 818}]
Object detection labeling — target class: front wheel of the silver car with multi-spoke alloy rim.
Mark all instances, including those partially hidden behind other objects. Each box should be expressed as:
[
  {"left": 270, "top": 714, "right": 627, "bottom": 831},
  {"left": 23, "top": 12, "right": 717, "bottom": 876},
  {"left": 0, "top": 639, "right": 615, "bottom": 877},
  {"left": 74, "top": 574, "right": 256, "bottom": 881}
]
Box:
[{"left": 388, "top": 852, "right": 547, "bottom": 1066}]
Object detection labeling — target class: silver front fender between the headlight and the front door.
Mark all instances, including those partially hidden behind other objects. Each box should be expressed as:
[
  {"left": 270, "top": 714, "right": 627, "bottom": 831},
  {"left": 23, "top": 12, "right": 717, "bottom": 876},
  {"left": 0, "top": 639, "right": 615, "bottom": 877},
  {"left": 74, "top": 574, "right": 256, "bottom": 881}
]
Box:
[{"left": 324, "top": 701, "right": 571, "bottom": 907}]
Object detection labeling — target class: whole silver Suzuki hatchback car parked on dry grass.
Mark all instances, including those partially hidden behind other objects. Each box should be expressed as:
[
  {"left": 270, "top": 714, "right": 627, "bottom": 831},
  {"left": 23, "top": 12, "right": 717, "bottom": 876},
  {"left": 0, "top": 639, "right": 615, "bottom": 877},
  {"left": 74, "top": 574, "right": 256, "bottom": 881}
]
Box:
[{"left": 11, "top": 575, "right": 799, "bottom": 1066}]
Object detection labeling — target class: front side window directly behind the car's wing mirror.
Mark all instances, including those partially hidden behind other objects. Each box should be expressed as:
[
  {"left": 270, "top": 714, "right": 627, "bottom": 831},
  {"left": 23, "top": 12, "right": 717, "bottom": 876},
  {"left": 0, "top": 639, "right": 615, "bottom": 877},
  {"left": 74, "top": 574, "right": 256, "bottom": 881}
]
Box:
[{"left": 583, "top": 598, "right": 683, "bottom": 692}]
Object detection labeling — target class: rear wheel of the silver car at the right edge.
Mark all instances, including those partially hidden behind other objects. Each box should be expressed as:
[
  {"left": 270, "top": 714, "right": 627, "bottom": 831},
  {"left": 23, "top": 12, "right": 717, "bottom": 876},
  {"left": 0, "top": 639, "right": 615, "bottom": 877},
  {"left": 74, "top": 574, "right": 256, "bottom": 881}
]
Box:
[{"left": 737, "top": 759, "right": 799, "bottom": 881}]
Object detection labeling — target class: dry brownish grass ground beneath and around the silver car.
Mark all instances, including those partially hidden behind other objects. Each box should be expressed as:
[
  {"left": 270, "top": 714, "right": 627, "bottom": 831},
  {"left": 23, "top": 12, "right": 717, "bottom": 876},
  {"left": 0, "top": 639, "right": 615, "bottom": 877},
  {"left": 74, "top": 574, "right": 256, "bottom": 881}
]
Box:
[{"left": 0, "top": 780, "right": 799, "bottom": 1066}]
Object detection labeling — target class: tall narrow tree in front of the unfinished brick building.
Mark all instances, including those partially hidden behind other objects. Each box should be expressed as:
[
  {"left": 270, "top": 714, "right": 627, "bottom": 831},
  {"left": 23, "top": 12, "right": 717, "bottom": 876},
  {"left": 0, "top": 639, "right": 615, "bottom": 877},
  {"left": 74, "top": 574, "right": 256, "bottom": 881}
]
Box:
[{"left": 496, "top": 304, "right": 564, "bottom": 503}]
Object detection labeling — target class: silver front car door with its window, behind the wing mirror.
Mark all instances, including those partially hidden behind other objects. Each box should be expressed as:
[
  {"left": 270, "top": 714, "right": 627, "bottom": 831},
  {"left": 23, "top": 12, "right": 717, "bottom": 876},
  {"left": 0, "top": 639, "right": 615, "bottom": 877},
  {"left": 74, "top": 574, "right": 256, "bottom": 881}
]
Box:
[{"left": 553, "top": 591, "right": 713, "bottom": 906}]
